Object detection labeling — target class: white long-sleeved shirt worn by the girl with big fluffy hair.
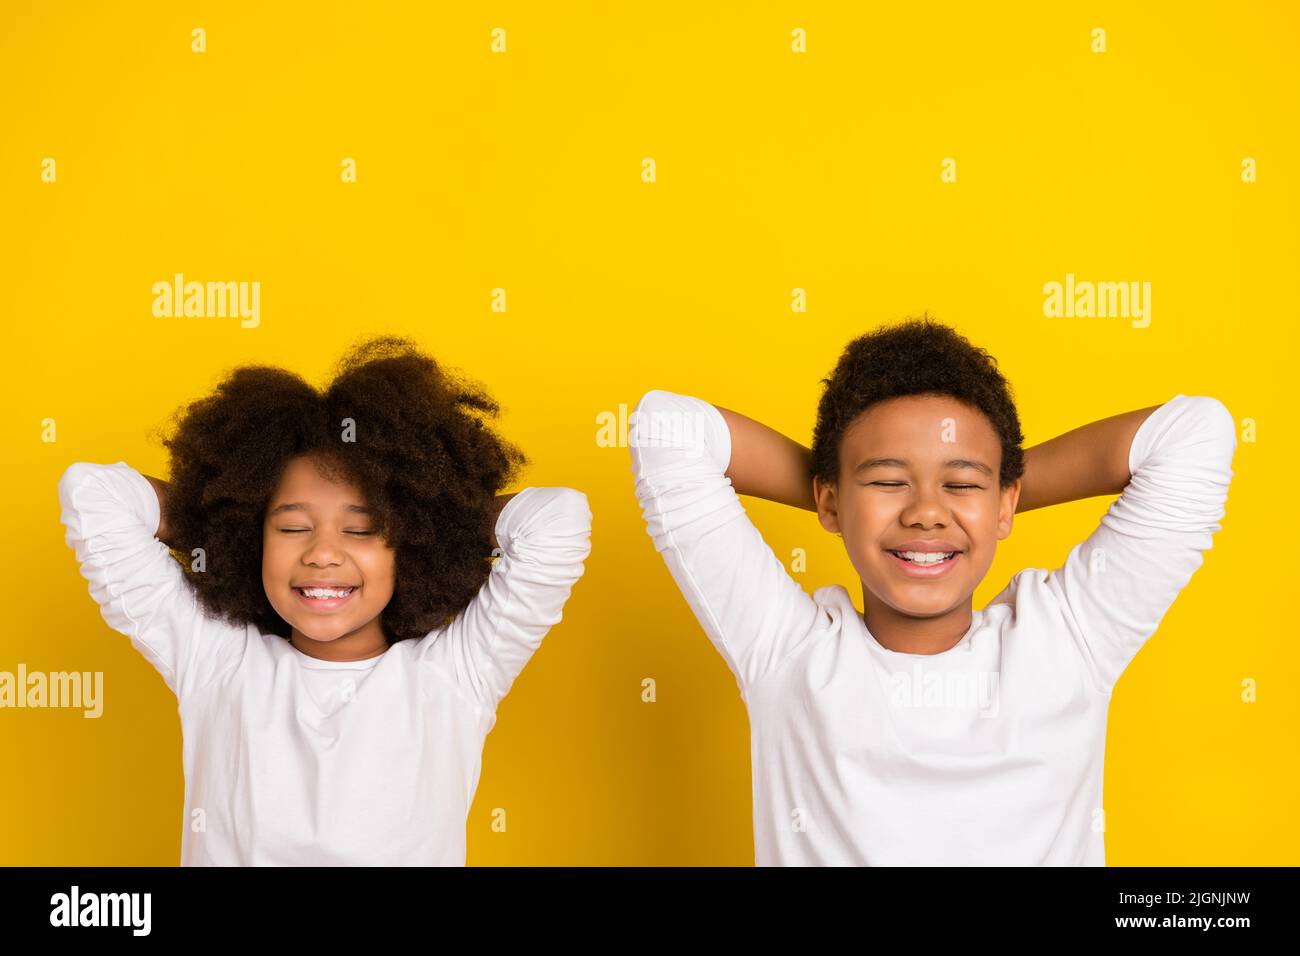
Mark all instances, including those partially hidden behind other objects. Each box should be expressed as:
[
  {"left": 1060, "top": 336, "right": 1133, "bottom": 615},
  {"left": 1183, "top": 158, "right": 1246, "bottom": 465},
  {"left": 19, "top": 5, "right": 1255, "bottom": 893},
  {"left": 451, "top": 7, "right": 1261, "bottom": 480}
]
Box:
[{"left": 59, "top": 462, "right": 592, "bottom": 866}]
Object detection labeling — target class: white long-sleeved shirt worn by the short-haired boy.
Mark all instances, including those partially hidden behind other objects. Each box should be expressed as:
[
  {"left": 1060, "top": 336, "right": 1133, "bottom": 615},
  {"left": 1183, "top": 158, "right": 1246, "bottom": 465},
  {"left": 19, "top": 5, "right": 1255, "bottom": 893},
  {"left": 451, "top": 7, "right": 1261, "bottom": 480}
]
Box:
[{"left": 629, "top": 390, "right": 1236, "bottom": 865}]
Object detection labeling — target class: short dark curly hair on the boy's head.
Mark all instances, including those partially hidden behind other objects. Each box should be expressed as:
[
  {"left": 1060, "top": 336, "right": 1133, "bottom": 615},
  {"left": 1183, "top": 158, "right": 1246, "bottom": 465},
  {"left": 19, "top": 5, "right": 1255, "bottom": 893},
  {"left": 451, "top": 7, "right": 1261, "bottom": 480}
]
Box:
[{"left": 813, "top": 312, "right": 1024, "bottom": 489}]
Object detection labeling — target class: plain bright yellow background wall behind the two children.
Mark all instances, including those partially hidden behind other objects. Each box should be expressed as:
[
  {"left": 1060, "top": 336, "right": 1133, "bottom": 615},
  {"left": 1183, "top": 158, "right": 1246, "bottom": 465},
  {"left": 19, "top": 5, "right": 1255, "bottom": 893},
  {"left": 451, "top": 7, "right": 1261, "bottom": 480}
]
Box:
[{"left": 0, "top": 1, "right": 1300, "bottom": 865}]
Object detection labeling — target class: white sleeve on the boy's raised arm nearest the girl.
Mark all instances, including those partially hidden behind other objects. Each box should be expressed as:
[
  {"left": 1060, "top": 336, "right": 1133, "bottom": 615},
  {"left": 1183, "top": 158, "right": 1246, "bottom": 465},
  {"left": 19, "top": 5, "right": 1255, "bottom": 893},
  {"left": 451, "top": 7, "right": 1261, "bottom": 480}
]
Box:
[{"left": 628, "top": 389, "right": 820, "bottom": 696}]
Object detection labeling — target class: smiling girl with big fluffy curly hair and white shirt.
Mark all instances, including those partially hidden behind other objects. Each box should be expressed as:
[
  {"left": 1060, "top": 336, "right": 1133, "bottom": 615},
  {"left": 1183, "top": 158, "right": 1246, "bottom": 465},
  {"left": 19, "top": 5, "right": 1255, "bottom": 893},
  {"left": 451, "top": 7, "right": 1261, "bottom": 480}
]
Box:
[{"left": 59, "top": 338, "right": 592, "bottom": 865}]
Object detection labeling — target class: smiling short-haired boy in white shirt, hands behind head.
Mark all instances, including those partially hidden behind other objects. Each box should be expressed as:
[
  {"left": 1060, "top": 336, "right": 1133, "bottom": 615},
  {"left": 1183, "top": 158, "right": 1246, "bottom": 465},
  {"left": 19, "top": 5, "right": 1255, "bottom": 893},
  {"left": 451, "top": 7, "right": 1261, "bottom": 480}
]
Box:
[{"left": 629, "top": 317, "right": 1236, "bottom": 865}]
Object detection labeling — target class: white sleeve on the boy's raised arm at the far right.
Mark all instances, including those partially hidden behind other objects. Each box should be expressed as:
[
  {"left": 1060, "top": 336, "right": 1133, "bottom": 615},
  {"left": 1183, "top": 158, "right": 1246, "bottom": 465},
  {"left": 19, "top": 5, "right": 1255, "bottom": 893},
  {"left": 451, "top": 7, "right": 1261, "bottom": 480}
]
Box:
[{"left": 1045, "top": 394, "right": 1236, "bottom": 693}]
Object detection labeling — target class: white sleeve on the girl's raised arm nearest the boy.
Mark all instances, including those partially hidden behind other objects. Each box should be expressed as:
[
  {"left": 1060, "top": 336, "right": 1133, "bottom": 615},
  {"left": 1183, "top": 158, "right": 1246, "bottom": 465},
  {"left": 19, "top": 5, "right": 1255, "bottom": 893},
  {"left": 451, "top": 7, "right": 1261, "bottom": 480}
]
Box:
[{"left": 423, "top": 486, "right": 592, "bottom": 711}]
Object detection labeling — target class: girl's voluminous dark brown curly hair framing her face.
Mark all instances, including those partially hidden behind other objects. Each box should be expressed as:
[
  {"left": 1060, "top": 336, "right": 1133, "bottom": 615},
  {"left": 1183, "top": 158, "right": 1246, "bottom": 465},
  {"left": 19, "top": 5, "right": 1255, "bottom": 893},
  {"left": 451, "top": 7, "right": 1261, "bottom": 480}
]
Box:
[{"left": 163, "top": 336, "right": 528, "bottom": 645}]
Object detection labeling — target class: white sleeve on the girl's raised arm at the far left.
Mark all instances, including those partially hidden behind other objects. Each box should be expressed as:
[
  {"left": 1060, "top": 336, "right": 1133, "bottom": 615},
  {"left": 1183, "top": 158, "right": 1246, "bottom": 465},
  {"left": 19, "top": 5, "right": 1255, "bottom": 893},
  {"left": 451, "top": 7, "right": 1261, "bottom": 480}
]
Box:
[{"left": 59, "top": 462, "right": 244, "bottom": 698}]
